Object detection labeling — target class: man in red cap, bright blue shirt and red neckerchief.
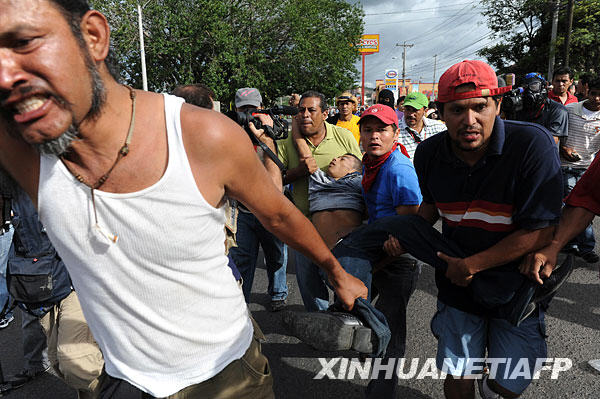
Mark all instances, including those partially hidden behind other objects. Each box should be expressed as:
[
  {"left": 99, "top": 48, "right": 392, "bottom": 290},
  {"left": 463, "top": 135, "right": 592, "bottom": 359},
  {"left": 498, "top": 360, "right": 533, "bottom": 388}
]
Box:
[{"left": 358, "top": 104, "right": 422, "bottom": 398}]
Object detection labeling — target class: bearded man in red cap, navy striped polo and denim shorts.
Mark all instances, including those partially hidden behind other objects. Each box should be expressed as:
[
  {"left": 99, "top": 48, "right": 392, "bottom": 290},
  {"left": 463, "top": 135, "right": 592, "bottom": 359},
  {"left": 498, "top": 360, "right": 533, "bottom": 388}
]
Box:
[{"left": 414, "top": 60, "right": 566, "bottom": 398}]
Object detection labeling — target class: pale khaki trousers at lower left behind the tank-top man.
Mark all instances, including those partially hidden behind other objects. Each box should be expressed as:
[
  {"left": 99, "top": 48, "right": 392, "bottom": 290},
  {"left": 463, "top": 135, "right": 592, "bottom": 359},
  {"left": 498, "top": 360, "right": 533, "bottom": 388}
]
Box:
[{"left": 40, "top": 291, "right": 104, "bottom": 399}]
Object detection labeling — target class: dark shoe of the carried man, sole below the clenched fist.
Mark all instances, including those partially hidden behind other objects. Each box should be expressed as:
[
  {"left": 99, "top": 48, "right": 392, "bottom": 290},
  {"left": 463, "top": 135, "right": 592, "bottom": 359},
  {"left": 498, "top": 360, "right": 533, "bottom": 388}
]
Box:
[{"left": 283, "top": 311, "right": 374, "bottom": 353}]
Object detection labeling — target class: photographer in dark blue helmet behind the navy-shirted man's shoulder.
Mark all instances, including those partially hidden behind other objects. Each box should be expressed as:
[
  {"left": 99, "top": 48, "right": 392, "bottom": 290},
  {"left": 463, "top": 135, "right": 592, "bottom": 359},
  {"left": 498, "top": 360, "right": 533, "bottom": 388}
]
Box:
[{"left": 502, "top": 72, "right": 569, "bottom": 144}]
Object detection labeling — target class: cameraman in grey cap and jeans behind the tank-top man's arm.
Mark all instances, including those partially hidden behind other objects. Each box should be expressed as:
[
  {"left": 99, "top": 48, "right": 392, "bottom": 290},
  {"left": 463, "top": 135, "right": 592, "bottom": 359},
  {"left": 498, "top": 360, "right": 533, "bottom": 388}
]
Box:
[{"left": 229, "top": 88, "right": 288, "bottom": 311}]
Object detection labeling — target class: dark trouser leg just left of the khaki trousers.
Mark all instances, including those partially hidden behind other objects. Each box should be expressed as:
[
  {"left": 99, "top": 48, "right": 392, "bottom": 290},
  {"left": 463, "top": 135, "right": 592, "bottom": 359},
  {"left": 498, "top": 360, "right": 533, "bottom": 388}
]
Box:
[{"left": 21, "top": 311, "right": 50, "bottom": 374}]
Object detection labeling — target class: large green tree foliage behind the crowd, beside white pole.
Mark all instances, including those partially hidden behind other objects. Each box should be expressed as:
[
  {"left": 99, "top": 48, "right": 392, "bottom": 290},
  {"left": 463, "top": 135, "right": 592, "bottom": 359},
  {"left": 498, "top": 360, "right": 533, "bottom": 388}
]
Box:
[{"left": 92, "top": 0, "right": 363, "bottom": 105}]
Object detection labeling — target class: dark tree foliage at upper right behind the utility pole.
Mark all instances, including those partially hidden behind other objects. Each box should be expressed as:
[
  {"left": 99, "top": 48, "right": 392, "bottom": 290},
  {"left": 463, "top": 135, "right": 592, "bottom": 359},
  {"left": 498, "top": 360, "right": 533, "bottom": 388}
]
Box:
[{"left": 479, "top": 0, "right": 600, "bottom": 76}]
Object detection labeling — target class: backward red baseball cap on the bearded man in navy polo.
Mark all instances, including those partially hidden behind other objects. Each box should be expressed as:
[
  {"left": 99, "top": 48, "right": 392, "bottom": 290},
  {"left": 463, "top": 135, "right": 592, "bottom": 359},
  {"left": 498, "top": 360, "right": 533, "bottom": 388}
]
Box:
[{"left": 437, "top": 60, "right": 512, "bottom": 103}]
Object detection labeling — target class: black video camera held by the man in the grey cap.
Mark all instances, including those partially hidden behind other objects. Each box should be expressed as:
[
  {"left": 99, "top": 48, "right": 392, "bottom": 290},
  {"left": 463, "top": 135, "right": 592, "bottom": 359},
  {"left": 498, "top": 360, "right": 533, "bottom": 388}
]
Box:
[{"left": 225, "top": 105, "right": 298, "bottom": 143}]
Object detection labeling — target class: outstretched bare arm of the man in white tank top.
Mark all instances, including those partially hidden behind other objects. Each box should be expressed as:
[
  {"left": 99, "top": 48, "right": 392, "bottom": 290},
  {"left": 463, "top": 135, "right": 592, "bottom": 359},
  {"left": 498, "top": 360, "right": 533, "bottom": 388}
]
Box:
[{"left": 182, "top": 110, "right": 367, "bottom": 308}]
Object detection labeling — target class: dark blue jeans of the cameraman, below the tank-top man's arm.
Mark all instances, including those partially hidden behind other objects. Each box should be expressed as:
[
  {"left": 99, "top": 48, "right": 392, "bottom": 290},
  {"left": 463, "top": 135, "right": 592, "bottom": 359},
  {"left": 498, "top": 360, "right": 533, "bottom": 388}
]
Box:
[{"left": 229, "top": 211, "right": 288, "bottom": 303}]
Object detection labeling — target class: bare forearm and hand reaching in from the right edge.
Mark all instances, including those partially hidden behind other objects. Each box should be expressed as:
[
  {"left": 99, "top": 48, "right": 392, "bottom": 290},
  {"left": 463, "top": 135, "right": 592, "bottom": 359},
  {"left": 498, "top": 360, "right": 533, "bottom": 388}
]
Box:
[{"left": 520, "top": 206, "right": 595, "bottom": 284}]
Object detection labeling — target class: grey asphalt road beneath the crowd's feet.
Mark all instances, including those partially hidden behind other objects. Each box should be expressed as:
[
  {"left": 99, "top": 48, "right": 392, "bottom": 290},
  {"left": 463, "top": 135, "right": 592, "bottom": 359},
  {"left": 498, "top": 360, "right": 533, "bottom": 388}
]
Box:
[{"left": 0, "top": 223, "right": 600, "bottom": 399}]
